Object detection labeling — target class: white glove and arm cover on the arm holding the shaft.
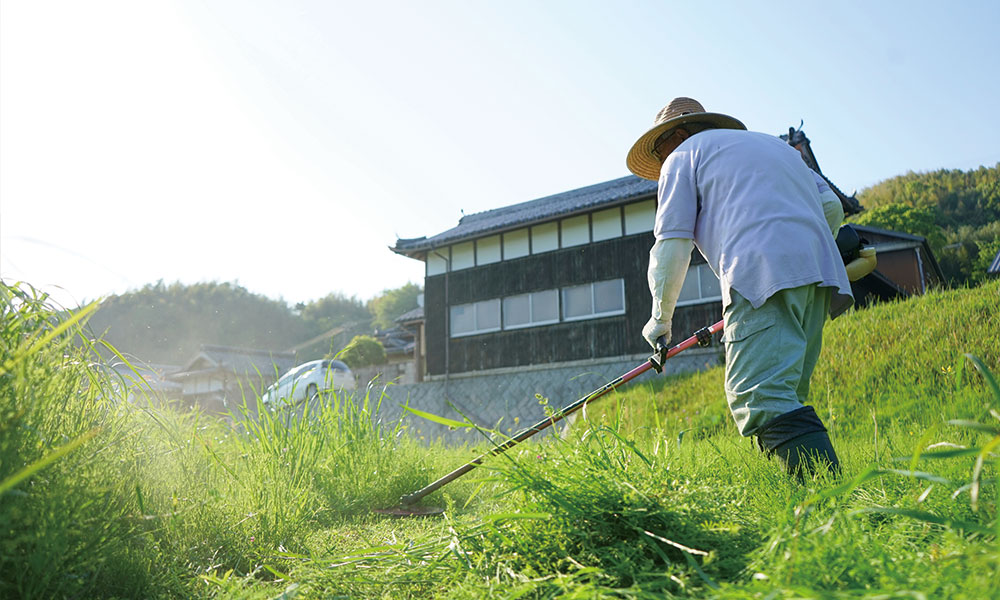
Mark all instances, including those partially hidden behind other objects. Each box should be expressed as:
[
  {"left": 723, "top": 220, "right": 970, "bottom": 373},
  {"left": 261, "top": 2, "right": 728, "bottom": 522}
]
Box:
[{"left": 642, "top": 238, "right": 691, "bottom": 350}]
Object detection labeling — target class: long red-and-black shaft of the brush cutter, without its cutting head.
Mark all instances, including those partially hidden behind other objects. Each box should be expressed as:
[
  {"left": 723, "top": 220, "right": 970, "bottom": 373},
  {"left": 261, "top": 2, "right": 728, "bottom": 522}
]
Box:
[{"left": 400, "top": 321, "right": 723, "bottom": 506}]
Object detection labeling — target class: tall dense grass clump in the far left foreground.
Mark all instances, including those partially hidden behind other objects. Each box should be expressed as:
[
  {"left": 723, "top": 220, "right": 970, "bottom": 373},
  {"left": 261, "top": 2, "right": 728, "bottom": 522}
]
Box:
[{"left": 0, "top": 284, "right": 168, "bottom": 598}]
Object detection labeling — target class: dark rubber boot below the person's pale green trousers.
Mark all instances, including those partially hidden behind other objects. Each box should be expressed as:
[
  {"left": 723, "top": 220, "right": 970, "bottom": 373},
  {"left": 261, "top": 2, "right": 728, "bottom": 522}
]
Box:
[{"left": 757, "top": 406, "right": 840, "bottom": 480}]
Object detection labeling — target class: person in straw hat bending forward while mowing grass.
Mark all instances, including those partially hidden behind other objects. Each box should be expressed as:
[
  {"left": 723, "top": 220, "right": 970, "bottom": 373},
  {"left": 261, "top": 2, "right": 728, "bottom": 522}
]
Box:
[{"left": 626, "top": 98, "right": 868, "bottom": 477}]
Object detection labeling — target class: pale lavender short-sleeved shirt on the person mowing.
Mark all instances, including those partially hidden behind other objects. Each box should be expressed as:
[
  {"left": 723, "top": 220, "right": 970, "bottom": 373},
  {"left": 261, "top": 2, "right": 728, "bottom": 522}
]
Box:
[{"left": 653, "top": 129, "right": 853, "bottom": 316}]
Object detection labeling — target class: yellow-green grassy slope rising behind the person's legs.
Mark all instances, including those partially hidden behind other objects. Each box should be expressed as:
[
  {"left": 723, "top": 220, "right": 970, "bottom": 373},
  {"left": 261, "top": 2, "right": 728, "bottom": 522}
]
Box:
[{"left": 600, "top": 281, "right": 1000, "bottom": 437}]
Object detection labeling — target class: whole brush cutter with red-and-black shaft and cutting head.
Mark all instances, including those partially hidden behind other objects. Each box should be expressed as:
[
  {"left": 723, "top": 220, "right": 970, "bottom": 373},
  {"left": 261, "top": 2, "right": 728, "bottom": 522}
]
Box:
[{"left": 374, "top": 321, "right": 723, "bottom": 517}]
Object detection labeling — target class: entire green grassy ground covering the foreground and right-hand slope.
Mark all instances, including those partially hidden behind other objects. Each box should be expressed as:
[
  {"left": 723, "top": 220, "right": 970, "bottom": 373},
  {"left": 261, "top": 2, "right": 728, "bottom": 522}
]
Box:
[{"left": 0, "top": 281, "right": 1000, "bottom": 598}]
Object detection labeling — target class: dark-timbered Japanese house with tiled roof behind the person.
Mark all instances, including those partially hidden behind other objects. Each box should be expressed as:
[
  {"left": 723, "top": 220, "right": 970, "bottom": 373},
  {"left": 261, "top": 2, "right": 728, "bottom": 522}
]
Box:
[{"left": 391, "top": 129, "right": 941, "bottom": 378}]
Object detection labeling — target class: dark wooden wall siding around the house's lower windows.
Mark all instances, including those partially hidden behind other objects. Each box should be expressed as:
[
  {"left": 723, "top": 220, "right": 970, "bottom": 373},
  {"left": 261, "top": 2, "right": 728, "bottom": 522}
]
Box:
[{"left": 424, "top": 233, "right": 722, "bottom": 375}]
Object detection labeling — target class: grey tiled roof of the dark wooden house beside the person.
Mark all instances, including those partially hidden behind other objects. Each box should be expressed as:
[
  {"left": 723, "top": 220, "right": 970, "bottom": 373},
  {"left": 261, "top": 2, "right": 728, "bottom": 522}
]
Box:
[{"left": 392, "top": 175, "right": 656, "bottom": 256}]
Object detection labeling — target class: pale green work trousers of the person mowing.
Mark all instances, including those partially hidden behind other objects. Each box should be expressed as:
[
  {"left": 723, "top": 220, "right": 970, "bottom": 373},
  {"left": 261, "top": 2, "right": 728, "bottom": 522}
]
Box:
[{"left": 722, "top": 284, "right": 831, "bottom": 436}]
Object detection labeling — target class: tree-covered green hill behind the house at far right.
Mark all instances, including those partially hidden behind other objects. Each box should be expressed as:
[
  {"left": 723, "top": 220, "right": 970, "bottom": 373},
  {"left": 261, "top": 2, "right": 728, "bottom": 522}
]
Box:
[{"left": 853, "top": 164, "right": 1000, "bottom": 286}]
